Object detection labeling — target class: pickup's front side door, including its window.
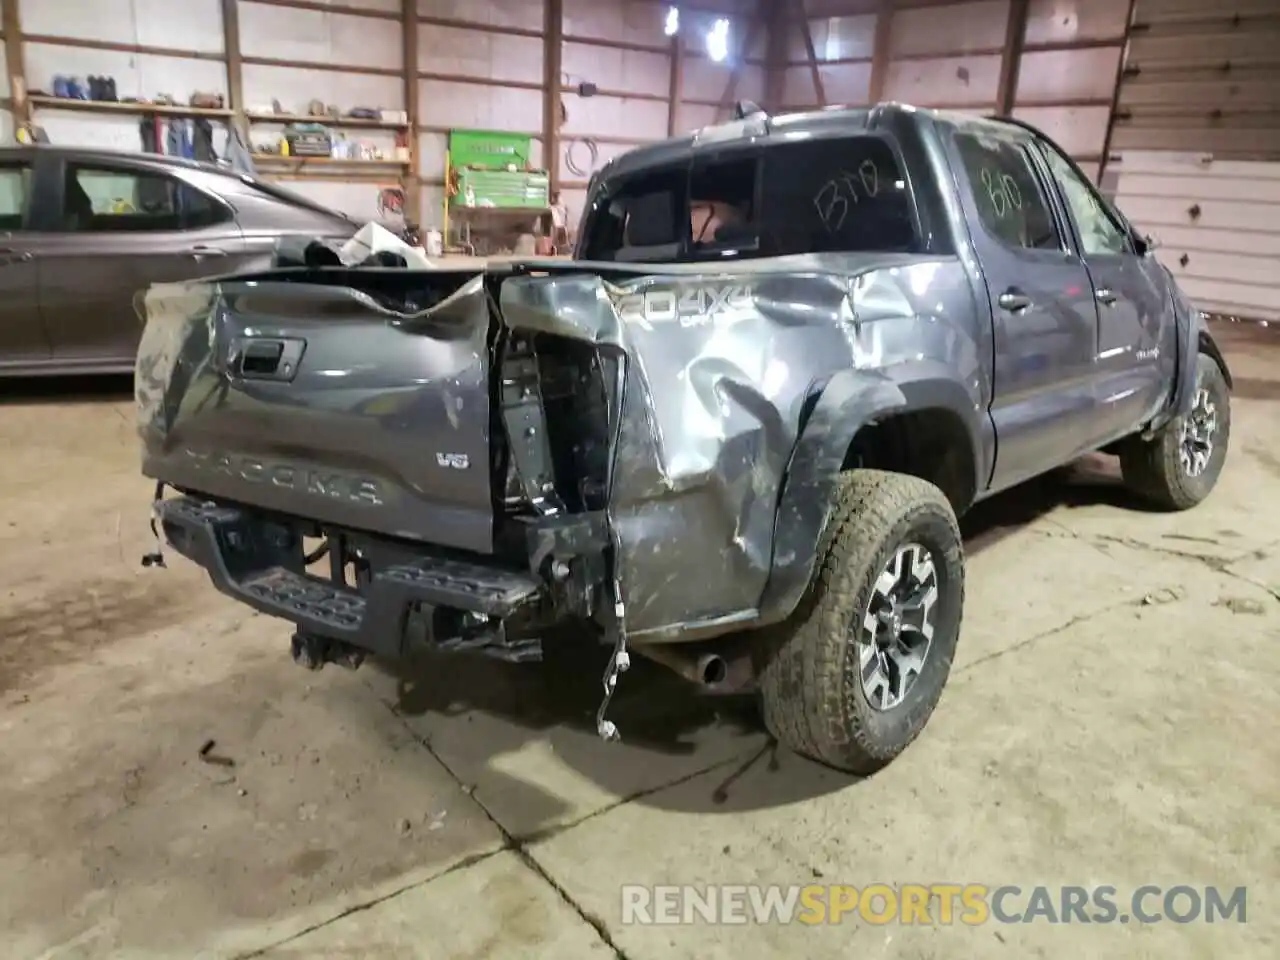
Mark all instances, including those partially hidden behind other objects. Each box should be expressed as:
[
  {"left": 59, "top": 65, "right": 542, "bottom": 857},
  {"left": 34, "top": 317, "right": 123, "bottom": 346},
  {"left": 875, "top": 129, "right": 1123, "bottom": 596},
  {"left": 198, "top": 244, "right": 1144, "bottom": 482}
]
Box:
[{"left": 1037, "top": 137, "right": 1176, "bottom": 447}]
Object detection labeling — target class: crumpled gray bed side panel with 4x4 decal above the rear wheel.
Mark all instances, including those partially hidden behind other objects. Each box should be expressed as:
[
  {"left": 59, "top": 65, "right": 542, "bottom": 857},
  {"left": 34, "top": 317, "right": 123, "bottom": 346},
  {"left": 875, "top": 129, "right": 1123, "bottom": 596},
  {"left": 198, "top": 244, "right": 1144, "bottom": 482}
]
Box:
[{"left": 499, "top": 256, "right": 982, "bottom": 639}]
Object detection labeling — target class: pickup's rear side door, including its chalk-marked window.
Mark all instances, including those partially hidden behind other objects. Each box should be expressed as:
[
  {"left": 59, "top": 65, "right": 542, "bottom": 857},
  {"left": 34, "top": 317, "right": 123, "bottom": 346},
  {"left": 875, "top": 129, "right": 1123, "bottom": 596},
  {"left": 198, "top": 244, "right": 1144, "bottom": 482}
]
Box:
[{"left": 948, "top": 120, "right": 1098, "bottom": 490}]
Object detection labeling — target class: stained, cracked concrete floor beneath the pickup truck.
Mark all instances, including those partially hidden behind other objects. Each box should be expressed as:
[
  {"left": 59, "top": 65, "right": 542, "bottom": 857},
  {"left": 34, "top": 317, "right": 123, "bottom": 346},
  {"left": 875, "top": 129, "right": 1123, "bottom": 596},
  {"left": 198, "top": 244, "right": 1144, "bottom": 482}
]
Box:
[{"left": 0, "top": 326, "right": 1280, "bottom": 960}]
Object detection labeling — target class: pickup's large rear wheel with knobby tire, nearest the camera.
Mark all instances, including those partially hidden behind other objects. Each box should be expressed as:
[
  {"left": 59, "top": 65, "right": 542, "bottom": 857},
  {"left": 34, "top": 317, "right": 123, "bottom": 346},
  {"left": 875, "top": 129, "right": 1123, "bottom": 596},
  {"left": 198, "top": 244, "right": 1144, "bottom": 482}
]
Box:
[{"left": 760, "top": 470, "right": 964, "bottom": 776}]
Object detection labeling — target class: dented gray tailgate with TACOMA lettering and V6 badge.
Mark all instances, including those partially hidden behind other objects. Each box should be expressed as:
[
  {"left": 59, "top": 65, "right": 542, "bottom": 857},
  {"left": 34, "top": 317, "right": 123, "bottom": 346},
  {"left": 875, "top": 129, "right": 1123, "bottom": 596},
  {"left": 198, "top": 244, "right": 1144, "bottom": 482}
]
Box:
[{"left": 136, "top": 270, "right": 494, "bottom": 553}]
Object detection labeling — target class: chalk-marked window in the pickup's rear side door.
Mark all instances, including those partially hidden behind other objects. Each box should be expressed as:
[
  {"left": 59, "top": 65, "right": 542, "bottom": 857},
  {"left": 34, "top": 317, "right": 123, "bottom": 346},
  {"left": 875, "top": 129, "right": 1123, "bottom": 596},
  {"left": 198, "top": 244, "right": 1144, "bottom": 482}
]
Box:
[{"left": 956, "top": 129, "right": 1062, "bottom": 256}]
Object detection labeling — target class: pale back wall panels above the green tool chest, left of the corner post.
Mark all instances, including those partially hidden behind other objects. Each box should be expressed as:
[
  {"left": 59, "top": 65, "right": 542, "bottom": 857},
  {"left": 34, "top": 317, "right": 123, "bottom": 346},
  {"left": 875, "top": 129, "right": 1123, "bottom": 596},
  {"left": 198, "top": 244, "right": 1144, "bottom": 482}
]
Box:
[{"left": 414, "top": 0, "right": 765, "bottom": 225}]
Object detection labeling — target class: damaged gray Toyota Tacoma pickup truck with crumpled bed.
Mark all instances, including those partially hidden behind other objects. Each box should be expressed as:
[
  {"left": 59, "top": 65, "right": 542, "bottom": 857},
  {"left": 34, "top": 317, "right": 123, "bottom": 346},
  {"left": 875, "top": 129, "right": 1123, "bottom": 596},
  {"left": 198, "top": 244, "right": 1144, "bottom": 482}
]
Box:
[{"left": 137, "top": 105, "right": 1230, "bottom": 773}]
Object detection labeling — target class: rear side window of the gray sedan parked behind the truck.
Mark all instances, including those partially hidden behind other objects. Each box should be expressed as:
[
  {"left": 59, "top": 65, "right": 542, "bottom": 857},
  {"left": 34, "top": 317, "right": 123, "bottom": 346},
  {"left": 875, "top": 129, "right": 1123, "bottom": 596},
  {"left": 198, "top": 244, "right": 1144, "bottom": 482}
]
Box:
[{"left": 63, "top": 164, "right": 230, "bottom": 233}]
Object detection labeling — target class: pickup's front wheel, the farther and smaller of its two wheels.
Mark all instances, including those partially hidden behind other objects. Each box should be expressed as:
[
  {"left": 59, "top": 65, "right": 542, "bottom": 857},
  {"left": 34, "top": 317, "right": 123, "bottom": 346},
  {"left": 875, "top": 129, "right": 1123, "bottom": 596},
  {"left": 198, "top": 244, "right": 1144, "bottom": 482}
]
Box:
[{"left": 1120, "top": 353, "right": 1231, "bottom": 511}]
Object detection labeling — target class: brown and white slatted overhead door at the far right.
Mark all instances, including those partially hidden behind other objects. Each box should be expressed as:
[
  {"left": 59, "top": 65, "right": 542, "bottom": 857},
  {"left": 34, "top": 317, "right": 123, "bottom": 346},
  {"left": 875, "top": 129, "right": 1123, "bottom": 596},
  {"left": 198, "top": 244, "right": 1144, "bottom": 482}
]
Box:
[{"left": 1106, "top": 0, "right": 1280, "bottom": 320}]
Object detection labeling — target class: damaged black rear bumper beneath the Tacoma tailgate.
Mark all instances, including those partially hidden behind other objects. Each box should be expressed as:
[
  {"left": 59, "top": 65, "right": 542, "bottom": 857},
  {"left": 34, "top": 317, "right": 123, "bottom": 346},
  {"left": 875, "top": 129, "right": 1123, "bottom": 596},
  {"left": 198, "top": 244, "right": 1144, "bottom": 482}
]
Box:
[{"left": 156, "top": 497, "right": 598, "bottom": 657}]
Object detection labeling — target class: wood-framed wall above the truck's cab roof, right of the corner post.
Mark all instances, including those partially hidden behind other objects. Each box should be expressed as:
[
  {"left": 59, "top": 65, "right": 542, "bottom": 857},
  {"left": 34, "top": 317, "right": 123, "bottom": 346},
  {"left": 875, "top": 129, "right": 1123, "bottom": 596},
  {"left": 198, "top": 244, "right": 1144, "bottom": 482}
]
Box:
[{"left": 780, "top": 0, "right": 1129, "bottom": 177}]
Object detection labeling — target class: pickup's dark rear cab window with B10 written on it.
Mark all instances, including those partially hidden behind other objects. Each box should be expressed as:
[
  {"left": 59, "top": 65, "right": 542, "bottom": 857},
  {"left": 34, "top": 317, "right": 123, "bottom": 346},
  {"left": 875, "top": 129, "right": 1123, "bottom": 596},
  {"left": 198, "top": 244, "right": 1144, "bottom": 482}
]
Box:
[{"left": 584, "top": 133, "right": 920, "bottom": 261}]
